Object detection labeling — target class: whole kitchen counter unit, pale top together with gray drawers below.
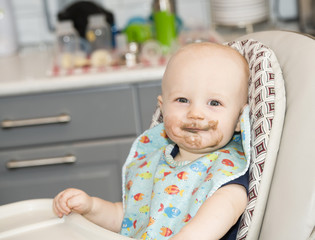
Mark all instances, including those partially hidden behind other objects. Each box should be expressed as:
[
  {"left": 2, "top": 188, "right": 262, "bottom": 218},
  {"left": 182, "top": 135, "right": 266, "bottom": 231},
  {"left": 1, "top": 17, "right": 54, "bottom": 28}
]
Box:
[{"left": 0, "top": 47, "right": 165, "bottom": 206}]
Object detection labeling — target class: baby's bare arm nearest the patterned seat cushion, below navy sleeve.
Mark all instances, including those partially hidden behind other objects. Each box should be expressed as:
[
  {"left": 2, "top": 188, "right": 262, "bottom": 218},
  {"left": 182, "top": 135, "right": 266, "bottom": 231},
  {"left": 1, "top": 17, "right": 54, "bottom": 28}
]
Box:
[{"left": 171, "top": 184, "right": 247, "bottom": 240}]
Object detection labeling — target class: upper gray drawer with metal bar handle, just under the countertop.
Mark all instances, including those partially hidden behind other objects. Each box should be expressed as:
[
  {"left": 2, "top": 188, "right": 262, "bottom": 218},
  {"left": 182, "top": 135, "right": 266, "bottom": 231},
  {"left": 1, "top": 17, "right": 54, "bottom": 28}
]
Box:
[{"left": 0, "top": 86, "right": 136, "bottom": 149}]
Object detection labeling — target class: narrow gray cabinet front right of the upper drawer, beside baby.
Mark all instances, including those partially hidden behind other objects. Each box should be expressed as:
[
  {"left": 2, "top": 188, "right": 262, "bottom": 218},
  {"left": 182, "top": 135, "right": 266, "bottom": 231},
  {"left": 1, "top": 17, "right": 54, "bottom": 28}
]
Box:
[{"left": 138, "top": 81, "right": 161, "bottom": 131}]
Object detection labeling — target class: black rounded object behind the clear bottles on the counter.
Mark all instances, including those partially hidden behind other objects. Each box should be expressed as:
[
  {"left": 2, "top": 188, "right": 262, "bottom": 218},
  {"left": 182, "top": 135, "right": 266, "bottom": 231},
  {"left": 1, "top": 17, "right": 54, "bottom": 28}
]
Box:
[{"left": 58, "top": 1, "right": 115, "bottom": 38}]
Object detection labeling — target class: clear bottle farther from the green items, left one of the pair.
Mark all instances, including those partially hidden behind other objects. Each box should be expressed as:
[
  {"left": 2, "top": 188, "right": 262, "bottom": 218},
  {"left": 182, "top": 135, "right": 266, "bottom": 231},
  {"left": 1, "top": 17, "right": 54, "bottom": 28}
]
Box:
[{"left": 56, "top": 20, "right": 79, "bottom": 69}]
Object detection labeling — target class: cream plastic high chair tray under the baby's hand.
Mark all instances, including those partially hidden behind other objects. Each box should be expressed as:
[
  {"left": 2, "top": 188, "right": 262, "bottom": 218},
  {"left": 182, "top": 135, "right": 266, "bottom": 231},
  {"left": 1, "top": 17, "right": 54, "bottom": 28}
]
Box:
[{"left": 0, "top": 199, "right": 131, "bottom": 240}]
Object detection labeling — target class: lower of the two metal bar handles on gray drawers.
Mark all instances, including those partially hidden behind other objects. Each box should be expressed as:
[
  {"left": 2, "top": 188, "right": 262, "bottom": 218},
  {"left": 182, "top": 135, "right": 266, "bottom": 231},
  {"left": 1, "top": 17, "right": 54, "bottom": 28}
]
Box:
[{"left": 6, "top": 155, "right": 77, "bottom": 169}]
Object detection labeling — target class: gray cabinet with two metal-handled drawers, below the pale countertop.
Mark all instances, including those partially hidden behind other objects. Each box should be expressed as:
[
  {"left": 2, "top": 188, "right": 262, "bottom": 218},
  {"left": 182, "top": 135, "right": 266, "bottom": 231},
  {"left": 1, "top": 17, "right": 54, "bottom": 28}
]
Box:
[{"left": 0, "top": 82, "right": 160, "bottom": 205}]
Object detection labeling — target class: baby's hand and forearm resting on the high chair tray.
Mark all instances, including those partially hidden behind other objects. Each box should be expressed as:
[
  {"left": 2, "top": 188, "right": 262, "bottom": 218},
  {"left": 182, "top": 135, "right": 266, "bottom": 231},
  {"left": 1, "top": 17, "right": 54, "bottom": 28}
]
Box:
[{"left": 53, "top": 188, "right": 123, "bottom": 232}]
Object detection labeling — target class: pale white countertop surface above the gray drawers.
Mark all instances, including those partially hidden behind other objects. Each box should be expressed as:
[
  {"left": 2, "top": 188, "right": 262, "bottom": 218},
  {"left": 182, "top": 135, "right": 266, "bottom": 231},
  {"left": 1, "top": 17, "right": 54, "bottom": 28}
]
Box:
[{"left": 0, "top": 48, "right": 165, "bottom": 97}]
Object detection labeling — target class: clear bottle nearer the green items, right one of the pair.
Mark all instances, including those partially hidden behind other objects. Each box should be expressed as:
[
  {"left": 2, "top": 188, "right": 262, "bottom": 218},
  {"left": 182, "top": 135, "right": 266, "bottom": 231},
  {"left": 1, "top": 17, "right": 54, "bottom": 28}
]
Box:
[{"left": 86, "top": 14, "right": 112, "bottom": 52}]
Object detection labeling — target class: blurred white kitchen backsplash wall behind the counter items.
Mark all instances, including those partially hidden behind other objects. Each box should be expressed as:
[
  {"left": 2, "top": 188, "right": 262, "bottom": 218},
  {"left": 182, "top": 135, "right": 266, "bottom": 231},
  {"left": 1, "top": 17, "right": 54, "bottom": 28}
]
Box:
[{"left": 12, "top": 0, "right": 210, "bottom": 46}]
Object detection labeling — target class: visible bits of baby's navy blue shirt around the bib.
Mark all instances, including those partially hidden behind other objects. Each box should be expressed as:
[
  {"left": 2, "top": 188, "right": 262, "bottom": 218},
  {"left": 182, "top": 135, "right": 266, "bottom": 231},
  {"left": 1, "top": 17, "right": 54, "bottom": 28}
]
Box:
[{"left": 171, "top": 145, "right": 249, "bottom": 240}]
